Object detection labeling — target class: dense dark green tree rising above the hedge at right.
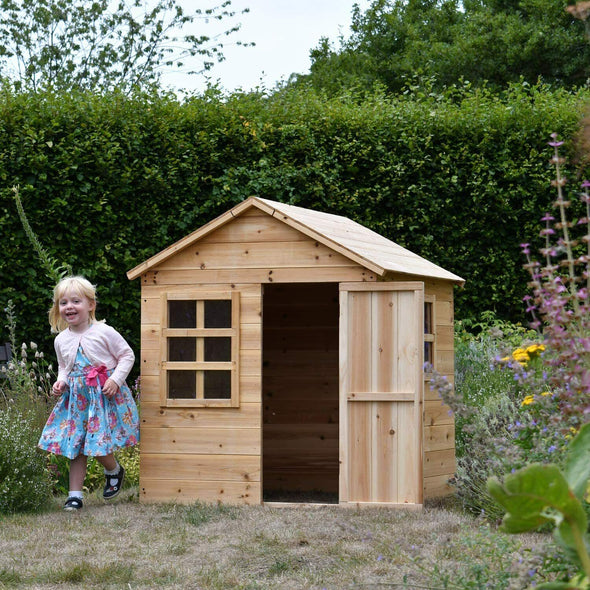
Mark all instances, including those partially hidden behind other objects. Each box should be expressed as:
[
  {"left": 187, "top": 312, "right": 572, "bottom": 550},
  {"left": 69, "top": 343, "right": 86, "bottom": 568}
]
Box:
[{"left": 298, "top": 0, "right": 590, "bottom": 92}]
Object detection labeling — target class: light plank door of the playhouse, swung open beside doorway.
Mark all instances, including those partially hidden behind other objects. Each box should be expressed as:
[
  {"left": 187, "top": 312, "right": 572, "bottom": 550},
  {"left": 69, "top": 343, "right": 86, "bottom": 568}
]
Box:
[{"left": 339, "top": 282, "right": 424, "bottom": 504}]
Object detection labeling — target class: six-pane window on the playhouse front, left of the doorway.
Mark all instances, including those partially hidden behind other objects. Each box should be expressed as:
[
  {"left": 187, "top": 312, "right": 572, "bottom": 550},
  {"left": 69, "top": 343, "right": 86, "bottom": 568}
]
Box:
[{"left": 160, "top": 292, "right": 240, "bottom": 407}]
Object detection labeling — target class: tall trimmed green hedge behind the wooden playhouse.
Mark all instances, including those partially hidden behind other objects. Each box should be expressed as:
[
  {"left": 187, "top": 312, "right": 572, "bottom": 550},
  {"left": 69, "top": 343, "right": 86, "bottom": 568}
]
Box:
[{"left": 0, "top": 85, "right": 587, "bottom": 374}]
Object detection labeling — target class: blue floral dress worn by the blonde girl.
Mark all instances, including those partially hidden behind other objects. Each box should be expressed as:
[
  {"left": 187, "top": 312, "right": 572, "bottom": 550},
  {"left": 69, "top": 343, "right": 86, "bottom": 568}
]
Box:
[{"left": 39, "top": 346, "right": 139, "bottom": 459}]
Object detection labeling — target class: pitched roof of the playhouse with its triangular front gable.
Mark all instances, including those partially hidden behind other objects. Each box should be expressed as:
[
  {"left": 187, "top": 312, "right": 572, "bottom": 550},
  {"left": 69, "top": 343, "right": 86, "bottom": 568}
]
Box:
[{"left": 127, "top": 197, "right": 464, "bottom": 284}]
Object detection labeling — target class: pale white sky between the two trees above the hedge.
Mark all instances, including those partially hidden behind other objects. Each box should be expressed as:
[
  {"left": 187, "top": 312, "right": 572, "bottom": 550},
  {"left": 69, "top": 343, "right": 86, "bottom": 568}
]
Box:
[{"left": 162, "top": 0, "right": 370, "bottom": 92}]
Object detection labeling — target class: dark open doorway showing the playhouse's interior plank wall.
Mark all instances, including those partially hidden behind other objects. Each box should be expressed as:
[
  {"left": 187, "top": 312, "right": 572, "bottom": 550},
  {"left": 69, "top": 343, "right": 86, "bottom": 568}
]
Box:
[{"left": 262, "top": 283, "right": 339, "bottom": 501}]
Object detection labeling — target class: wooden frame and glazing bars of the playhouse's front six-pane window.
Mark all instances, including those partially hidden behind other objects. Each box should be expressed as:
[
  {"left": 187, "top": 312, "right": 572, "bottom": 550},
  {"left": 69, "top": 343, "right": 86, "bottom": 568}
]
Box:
[{"left": 160, "top": 290, "right": 240, "bottom": 408}]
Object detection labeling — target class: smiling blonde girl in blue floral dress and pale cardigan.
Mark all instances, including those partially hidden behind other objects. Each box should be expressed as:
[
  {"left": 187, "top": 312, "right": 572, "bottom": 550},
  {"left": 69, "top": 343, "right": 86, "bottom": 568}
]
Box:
[{"left": 39, "top": 276, "right": 139, "bottom": 511}]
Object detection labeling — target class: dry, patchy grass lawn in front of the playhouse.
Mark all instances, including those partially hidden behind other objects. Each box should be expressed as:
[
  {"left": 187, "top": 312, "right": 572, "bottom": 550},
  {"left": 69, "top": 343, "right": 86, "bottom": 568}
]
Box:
[{"left": 0, "top": 491, "right": 564, "bottom": 590}]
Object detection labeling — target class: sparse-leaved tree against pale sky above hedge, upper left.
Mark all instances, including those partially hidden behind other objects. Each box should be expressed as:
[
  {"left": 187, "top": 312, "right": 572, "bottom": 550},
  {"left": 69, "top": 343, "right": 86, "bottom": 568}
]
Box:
[{"left": 0, "top": 0, "right": 248, "bottom": 93}]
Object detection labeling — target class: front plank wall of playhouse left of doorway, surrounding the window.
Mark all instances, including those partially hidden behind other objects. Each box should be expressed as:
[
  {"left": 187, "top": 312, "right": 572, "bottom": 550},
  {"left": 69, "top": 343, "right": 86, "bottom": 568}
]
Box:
[{"left": 140, "top": 284, "right": 262, "bottom": 504}]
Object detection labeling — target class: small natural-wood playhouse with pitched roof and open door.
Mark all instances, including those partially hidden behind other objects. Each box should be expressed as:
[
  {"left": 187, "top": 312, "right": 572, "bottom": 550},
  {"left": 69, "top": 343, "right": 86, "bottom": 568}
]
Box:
[{"left": 128, "top": 197, "right": 463, "bottom": 506}]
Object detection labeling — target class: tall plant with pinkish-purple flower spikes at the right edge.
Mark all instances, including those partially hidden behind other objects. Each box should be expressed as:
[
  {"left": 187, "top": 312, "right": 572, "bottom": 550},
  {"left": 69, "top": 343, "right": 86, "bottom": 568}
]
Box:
[{"left": 522, "top": 134, "right": 590, "bottom": 434}]
